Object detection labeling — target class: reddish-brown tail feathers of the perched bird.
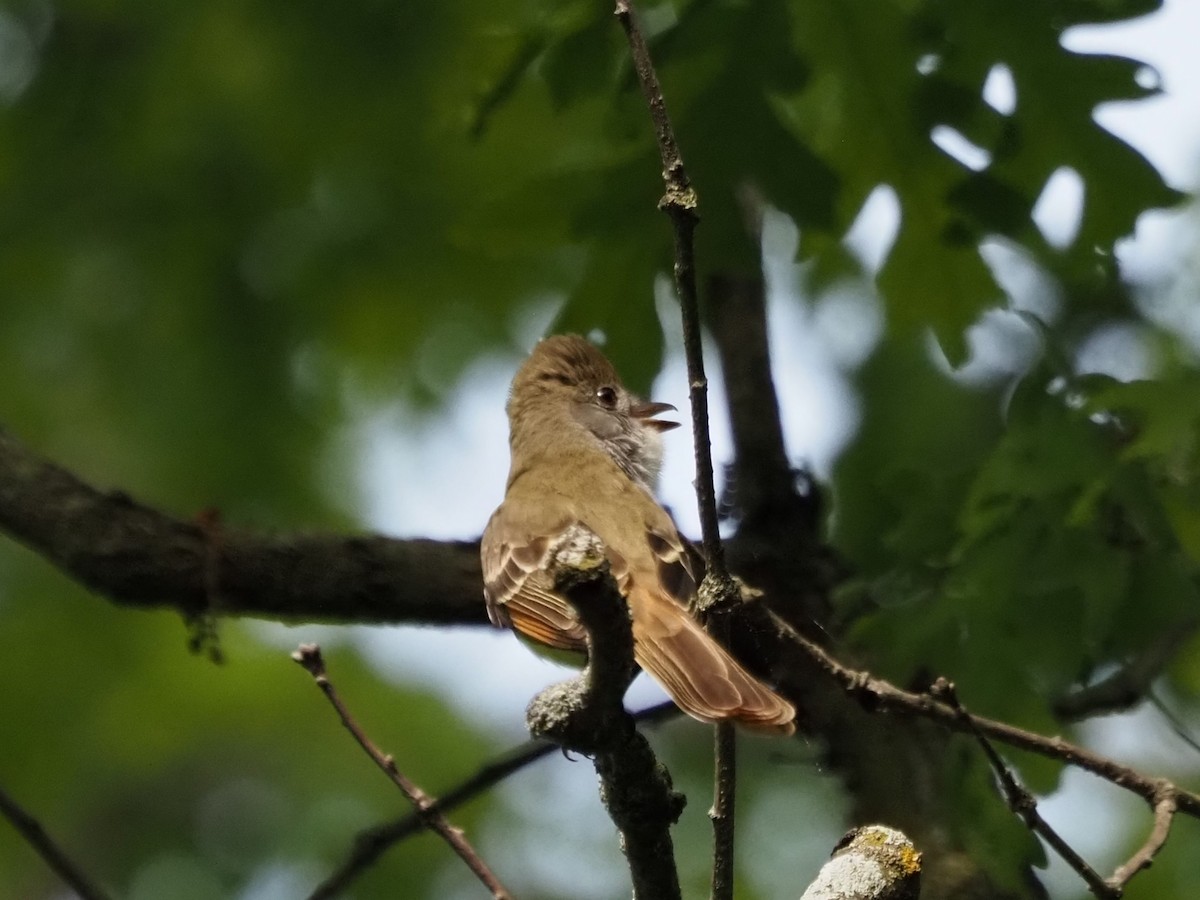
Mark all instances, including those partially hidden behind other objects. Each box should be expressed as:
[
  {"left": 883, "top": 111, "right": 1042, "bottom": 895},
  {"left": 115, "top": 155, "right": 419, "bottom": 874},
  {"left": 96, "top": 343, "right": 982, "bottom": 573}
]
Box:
[{"left": 628, "top": 584, "right": 796, "bottom": 734}]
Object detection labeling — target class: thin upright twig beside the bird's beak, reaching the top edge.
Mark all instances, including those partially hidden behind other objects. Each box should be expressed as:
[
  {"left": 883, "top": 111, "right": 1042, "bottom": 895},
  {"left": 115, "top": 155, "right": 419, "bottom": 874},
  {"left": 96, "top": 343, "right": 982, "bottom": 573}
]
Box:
[{"left": 616, "top": 0, "right": 738, "bottom": 900}]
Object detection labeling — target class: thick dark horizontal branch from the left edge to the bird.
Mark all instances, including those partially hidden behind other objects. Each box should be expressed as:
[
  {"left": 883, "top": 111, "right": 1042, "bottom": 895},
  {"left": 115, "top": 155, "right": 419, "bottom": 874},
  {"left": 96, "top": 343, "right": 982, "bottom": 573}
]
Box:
[{"left": 0, "top": 428, "right": 487, "bottom": 625}]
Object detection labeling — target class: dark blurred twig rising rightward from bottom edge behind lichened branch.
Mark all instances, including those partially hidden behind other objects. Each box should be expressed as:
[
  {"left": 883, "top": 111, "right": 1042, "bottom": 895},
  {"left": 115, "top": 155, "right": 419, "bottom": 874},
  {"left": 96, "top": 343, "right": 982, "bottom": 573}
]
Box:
[{"left": 307, "top": 700, "right": 683, "bottom": 900}]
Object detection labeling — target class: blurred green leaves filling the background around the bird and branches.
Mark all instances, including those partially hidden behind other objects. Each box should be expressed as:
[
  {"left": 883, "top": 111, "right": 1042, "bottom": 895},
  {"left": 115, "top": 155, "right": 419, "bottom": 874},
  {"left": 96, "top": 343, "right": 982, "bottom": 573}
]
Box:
[{"left": 0, "top": 0, "right": 1200, "bottom": 899}]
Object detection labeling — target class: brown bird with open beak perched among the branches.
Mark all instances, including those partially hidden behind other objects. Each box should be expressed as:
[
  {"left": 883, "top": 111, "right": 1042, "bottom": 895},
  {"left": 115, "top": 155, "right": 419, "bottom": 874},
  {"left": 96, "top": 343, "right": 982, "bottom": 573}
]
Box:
[{"left": 481, "top": 335, "right": 796, "bottom": 734}]
